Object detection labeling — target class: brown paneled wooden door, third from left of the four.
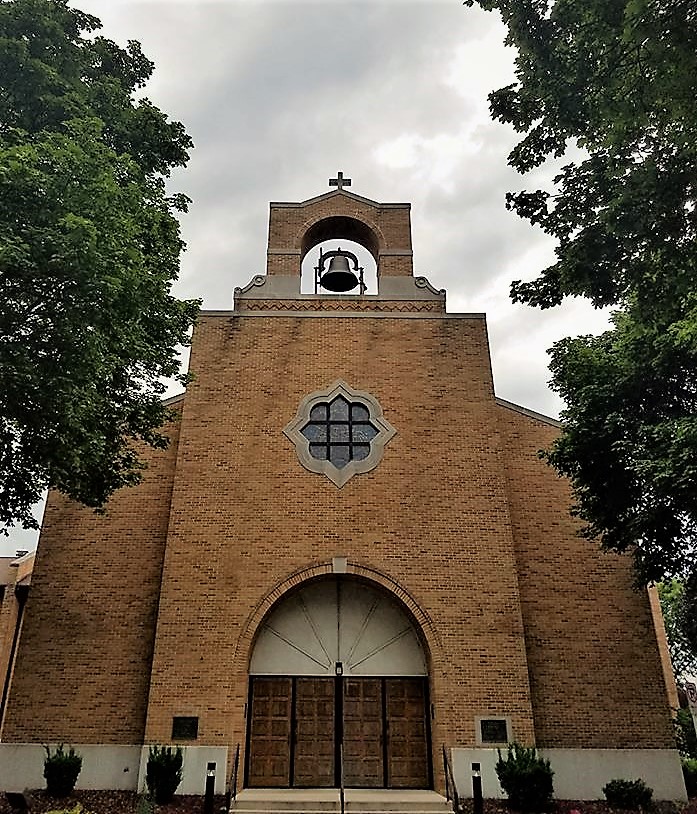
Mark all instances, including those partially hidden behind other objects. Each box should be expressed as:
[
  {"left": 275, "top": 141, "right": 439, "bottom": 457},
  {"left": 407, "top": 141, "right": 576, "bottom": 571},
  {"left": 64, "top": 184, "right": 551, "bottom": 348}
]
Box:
[{"left": 343, "top": 678, "right": 385, "bottom": 788}]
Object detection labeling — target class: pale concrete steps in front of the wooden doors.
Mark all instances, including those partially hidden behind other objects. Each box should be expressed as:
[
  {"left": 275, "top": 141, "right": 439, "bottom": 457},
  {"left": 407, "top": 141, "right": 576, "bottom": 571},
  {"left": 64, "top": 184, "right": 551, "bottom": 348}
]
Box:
[{"left": 231, "top": 789, "right": 452, "bottom": 814}]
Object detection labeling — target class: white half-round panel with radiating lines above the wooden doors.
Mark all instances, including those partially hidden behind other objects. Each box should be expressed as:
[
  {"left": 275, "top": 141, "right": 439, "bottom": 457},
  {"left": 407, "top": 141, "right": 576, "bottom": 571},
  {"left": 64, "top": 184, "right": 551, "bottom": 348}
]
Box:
[{"left": 249, "top": 576, "right": 428, "bottom": 676}]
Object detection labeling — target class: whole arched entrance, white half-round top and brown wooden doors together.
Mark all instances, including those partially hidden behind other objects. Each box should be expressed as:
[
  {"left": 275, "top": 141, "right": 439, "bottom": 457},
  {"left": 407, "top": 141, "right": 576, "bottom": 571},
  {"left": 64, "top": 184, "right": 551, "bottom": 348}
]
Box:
[{"left": 246, "top": 575, "right": 432, "bottom": 788}]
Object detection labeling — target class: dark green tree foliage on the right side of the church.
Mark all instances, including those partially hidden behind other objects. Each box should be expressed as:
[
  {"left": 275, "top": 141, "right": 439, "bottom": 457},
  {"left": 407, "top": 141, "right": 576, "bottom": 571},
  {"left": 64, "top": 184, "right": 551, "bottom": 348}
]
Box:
[{"left": 466, "top": 0, "right": 697, "bottom": 588}]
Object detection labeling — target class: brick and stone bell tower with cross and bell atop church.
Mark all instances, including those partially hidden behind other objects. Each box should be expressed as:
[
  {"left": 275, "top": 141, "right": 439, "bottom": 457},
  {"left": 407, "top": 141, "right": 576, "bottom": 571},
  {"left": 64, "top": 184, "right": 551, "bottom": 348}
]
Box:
[{"left": 235, "top": 172, "right": 445, "bottom": 312}]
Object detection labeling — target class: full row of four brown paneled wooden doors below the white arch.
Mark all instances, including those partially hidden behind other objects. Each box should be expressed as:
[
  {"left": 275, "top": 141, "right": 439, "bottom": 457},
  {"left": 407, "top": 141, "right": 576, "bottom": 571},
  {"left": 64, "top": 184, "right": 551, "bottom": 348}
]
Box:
[{"left": 246, "top": 676, "right": 432, "bottom": 788}]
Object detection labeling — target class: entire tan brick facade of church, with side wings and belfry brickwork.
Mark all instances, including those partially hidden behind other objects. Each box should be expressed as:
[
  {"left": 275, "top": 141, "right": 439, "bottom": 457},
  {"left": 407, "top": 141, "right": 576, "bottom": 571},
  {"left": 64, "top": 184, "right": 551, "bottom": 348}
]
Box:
[{"left": 3, "top": 190, "right": 672, "bottom": 766}]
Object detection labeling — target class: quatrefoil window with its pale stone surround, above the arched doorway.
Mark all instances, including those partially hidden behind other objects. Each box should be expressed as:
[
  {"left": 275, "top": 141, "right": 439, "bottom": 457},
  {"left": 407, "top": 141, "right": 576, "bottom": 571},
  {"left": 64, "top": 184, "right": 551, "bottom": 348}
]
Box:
[{"left": 284, "top": 381, "right": 395, "bottom": 487}]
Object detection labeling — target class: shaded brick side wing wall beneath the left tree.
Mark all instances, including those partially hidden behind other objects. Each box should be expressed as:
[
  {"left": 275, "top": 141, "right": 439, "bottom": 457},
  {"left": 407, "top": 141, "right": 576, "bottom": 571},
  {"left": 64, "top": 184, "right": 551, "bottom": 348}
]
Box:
[{"left": 2, "top": 414, "right": 178, "bottom": 743}]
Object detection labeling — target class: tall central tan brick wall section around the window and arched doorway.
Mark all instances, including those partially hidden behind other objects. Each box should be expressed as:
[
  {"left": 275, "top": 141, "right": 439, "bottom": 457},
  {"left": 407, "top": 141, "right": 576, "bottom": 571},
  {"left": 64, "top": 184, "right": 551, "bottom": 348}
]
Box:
[{"left": 140, "top": 316, "right": 533, "bottom": 764}]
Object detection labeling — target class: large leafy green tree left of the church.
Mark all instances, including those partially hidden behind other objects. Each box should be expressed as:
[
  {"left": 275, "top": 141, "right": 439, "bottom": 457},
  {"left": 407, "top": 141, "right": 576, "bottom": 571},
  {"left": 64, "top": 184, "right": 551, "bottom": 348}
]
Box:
[{"left": 0, "top": 0, "right": 197, "bottom": 527}]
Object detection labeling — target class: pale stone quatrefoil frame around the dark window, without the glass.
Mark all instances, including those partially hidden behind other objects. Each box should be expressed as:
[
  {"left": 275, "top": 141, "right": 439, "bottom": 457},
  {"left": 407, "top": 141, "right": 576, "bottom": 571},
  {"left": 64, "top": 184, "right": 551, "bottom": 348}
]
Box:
[{"left": 283, "top": 379, "right": 397, "bottom": 489}]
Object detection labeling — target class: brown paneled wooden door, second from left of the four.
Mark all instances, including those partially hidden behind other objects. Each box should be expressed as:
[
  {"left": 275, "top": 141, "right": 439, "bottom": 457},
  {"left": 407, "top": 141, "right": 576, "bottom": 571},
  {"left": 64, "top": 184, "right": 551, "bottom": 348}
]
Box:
[{"left": 293, "top": 678, "right": 336, "bottom": 788}]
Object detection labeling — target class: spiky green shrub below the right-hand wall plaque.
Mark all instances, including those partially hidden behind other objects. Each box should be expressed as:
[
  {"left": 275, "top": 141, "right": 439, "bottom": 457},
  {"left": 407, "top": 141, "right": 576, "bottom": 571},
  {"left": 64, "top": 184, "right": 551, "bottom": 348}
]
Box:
[{"left": 496, "top": 743, "right": 554, "bottom": 811}]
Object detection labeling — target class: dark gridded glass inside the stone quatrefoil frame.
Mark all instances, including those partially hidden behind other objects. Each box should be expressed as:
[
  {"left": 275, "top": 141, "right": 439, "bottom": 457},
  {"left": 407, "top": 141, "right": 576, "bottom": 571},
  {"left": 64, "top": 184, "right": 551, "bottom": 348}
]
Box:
[{"left": 300, "top": 396, "right": 378, "bottom": 469}]
